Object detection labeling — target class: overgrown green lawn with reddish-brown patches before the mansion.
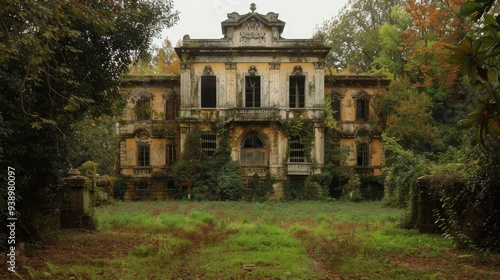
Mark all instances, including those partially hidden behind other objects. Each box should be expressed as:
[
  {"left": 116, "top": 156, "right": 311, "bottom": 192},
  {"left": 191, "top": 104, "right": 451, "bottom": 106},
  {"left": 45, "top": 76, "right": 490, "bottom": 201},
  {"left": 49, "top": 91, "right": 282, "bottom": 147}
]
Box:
[{"left": 15, "top": 201, "right": 496, "bottom": 279}]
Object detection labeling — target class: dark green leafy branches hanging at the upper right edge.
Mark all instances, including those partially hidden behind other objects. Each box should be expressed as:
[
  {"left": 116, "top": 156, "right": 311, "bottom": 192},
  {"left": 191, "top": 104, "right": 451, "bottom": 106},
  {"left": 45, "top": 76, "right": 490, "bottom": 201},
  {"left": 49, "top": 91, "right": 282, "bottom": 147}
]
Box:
[{"left": 448, "top": 0, "right": 500, "bottom": 144}]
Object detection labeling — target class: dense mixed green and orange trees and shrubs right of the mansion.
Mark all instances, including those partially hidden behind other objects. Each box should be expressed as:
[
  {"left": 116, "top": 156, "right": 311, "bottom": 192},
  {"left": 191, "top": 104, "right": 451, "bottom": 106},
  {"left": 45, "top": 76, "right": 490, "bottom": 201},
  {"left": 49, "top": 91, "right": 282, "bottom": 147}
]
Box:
[{"left": 318, "top": 0, "right": 500, "bottom": 248}]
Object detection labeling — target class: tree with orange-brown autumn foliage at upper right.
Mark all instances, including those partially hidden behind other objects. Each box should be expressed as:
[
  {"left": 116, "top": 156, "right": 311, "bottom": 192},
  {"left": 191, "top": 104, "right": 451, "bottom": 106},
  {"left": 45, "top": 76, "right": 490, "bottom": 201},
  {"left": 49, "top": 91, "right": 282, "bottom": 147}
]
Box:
[{"left": 403, "top": 0, "right": 468, "bottom": 91}]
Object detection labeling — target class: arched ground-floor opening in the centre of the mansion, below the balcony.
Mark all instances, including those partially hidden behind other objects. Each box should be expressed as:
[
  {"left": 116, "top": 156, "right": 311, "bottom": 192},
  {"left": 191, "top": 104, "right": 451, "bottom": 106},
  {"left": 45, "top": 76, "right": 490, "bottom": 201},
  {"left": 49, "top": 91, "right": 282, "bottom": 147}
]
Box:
[{"left": 240, "top": 133, "right": 267, "bottom": 166}]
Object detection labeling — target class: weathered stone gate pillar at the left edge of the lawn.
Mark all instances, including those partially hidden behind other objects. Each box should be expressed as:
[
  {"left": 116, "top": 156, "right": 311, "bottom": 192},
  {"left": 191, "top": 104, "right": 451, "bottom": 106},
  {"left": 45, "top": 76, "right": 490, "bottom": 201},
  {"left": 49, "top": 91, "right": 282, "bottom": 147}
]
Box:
[{"left": 61, "top": 169, "right": 97, "bottom": 229}]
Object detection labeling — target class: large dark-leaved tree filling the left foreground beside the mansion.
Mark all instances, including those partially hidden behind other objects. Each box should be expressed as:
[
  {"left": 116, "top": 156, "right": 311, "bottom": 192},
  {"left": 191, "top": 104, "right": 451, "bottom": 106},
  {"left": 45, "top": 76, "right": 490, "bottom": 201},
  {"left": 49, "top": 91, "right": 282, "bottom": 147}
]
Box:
[{"left": 0, "top": 0, "right": 178, "bottom": 240}]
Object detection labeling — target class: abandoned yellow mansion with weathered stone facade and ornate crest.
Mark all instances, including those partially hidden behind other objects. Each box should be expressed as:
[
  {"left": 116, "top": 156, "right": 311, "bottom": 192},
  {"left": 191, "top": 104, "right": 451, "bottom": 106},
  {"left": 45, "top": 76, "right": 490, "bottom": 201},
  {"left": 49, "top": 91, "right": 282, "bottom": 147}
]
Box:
[{"left": 116, "top": 5, "right": 390, "bottom": 199}]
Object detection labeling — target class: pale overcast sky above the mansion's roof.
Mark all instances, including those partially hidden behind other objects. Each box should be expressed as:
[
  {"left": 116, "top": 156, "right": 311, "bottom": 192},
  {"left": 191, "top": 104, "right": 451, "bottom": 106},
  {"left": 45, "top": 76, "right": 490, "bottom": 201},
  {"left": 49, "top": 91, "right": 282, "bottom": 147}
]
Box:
[{"left": 156, "top": 0, "right": 348, "bottom": 45}]
